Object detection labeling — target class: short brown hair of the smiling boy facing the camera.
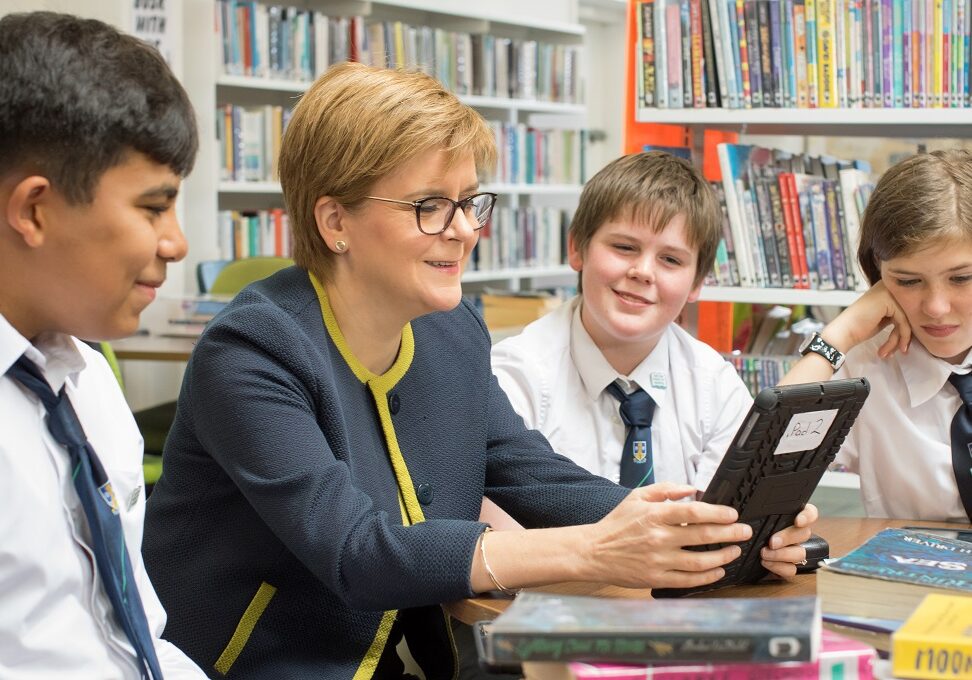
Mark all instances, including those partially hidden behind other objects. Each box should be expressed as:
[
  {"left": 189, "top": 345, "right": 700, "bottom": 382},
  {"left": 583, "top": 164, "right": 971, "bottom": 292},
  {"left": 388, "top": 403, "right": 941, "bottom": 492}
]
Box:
[{"left": 570, "top": 151, "right": 722, "bottom": 286}]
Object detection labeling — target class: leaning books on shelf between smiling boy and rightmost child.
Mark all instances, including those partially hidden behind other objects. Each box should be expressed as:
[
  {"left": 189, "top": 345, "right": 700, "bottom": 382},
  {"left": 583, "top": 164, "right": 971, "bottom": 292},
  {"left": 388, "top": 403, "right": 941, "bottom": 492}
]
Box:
[{"left": 709, "top": 144, "right": 873, "bottom": 290}]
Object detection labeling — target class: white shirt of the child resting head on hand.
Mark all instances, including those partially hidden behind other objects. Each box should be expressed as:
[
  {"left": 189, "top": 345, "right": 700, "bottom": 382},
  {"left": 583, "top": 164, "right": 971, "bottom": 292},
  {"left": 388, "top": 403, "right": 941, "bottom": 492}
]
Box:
[{"left": 834, "top": 331, "right": 972, "bottom": 522}]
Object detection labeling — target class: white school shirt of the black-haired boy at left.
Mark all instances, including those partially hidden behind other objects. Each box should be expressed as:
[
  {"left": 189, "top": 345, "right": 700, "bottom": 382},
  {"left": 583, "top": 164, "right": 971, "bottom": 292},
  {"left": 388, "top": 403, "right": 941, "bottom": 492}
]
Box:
[{"left": 0, "top": 315, "right": 205, "bottom": 680}]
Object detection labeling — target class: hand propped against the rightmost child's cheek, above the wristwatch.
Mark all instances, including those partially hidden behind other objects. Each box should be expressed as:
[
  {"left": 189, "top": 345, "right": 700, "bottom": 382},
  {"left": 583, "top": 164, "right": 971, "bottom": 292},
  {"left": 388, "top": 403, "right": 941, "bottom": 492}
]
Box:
[{"left": 822, "top": 281, "right": 911, "bottom": 359}]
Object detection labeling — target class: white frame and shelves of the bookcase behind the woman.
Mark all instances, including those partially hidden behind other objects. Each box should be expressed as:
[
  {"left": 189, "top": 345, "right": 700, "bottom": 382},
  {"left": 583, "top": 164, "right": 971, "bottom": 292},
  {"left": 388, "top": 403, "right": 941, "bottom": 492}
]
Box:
[{"left": 183, "top": 0, "right": 587, "bottom": 290}]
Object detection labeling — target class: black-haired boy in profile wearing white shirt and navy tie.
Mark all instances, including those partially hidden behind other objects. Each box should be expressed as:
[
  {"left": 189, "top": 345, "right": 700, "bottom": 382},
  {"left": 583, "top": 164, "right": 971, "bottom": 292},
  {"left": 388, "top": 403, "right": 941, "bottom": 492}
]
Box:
[{"left": 0, "top": 12, "right": 203, "bottom": 680}]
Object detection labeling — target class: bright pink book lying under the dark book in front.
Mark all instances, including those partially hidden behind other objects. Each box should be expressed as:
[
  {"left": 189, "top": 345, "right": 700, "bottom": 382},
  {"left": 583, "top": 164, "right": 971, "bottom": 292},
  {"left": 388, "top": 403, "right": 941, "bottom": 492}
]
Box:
[{"left": 568, "top": 630, "right": 875, "bottom": 680}]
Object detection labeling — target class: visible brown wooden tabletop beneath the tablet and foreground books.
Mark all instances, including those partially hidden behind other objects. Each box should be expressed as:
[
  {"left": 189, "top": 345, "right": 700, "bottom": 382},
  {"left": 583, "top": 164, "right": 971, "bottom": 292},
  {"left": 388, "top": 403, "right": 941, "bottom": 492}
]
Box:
[{"left": 446, "top": 517, "right": 965, "bottom": 624}]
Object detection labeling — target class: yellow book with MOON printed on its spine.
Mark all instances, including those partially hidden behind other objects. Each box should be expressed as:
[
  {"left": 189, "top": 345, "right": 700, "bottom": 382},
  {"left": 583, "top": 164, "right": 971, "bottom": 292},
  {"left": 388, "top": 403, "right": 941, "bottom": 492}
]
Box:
[{"left": 891, "top": 593, "right": 972, "bottom": 679}]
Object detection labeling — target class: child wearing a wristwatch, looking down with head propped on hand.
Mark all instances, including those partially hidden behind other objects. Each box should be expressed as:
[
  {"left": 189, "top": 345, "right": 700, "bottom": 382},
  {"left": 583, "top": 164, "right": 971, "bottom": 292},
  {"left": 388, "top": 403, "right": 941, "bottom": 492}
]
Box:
[{"left": 782, "top": 149, "right": 972, "bottom": 522}]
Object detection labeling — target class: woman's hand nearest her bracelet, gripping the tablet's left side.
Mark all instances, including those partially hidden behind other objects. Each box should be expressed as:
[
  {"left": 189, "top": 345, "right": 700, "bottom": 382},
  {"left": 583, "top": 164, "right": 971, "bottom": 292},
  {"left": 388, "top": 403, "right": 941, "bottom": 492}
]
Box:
[{"left": 586, "top": 483, "right": 752, "bottom": 588}]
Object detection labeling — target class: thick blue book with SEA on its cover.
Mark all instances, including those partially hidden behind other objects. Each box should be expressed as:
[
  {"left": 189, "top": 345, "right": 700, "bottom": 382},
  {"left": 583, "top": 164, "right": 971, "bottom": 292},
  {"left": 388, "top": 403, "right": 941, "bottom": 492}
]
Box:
[{"left": 817, "top": 529, "right": 972, "bottom": 620}]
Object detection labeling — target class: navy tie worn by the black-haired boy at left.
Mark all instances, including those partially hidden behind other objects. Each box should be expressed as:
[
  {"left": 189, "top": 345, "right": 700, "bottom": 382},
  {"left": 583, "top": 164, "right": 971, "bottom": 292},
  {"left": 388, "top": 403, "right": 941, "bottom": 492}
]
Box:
[{"left": 7, "top": 356, "right": 162, "bottom": 680}]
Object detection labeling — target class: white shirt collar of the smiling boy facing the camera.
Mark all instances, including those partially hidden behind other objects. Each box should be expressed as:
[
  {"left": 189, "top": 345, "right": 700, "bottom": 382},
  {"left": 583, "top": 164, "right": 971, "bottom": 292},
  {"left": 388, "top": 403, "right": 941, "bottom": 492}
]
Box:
[{"left": 570, "top": 297, "right": 669, "bottom": 404}]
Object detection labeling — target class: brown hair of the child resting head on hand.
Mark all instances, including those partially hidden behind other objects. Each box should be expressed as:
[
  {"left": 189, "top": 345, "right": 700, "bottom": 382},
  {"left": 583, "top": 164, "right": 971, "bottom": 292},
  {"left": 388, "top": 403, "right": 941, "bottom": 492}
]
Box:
[{"left": 857, "top": 149, "right": 972, "bottom": 285}]
